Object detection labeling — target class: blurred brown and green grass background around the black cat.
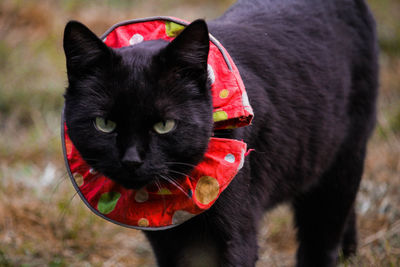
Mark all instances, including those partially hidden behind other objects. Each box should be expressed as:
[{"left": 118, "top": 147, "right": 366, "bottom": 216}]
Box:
[{"left": 0, "top": 0, "right": 400, "bottom": 267}]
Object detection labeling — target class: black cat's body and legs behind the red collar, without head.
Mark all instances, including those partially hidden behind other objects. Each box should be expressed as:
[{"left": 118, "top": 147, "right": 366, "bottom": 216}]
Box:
[{"left": 62, "top": 0, "right": 378, "bottom": 266}]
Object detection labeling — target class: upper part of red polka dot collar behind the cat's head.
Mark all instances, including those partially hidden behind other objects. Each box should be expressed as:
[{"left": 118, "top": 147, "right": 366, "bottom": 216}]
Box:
[{"left": 103, "top": 17, "right": 253, "bottom": 129}]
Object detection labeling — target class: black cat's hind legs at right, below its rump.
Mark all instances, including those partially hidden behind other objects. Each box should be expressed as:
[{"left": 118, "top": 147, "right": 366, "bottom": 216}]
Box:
[{"left": 293, "top": 148, "right": 365, "bottom": 267}]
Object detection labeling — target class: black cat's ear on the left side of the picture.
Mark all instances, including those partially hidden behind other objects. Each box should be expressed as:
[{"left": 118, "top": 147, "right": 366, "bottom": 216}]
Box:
[{"left": 64, "top": 21, "right": 111, "bottom": 76}]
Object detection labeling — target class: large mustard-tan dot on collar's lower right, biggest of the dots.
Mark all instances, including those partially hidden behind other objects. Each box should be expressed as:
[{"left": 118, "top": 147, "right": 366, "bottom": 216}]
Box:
[{"left": 194, "top": 176, "right": 219, "bottom": 205}]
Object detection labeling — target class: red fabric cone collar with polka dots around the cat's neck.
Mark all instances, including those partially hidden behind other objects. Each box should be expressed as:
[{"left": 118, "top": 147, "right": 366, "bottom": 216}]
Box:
[{"left": 61, "top": 17, "right": 253, "bottom": 230}]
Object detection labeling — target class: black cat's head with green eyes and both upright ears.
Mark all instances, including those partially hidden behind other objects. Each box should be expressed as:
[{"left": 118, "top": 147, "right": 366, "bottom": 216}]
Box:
[{"left": 64, "top": 21, "right": 212, "bottom": 188}]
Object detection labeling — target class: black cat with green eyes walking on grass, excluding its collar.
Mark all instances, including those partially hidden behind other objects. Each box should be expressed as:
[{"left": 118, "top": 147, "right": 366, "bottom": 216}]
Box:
[{"left": 64, "top": 0, "right": 378, "bottom": 267}]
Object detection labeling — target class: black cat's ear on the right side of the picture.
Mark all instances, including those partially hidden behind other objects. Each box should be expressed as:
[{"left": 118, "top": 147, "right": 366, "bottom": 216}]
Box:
[{"left": 166, "top": 19, "right": 210, "bottom": 73}]
